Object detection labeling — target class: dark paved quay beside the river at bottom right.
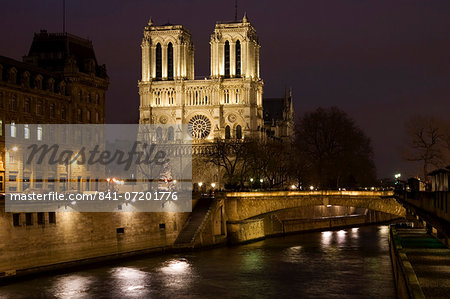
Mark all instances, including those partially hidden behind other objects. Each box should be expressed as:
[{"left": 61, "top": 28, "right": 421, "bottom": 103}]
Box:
[{"left": 391, "top": 226, "right": 450, "bottom": 298}]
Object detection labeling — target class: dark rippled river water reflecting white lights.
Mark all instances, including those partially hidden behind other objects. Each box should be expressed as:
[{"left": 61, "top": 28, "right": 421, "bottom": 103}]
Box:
[{"left": 0, "top": 226, "right": 395, "bottom": 298}]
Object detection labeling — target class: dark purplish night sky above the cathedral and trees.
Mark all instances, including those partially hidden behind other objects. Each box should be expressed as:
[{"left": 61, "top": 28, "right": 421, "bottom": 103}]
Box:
[{"left": 0, "top": 0, "right": 450, "bottom": 177}]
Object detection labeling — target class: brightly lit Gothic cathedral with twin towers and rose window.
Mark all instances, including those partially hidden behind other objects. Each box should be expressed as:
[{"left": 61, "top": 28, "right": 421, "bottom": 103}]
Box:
[{"left": 139, "top": 15, "right": 294, "bottom": 144}]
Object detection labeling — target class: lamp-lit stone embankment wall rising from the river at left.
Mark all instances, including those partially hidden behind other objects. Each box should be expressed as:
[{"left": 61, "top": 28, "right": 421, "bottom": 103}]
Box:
[{"left": 0, "top": 199, "right": 204, "bottom": 278}]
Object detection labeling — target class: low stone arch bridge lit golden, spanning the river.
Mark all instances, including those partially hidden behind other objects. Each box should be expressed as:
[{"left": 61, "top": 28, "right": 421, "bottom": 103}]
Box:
[{"left": 217, "top": 191, "right": 406, "bottom": 221}]
